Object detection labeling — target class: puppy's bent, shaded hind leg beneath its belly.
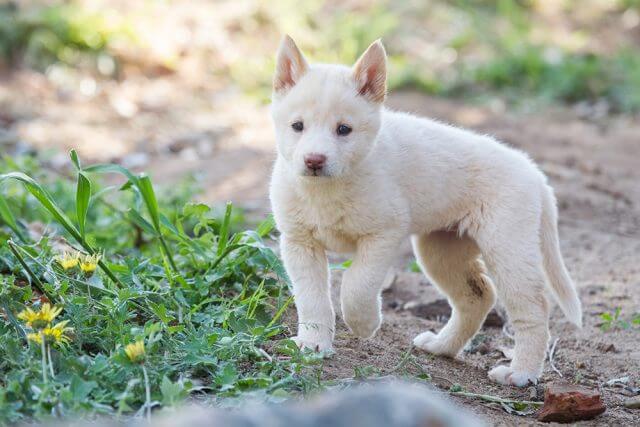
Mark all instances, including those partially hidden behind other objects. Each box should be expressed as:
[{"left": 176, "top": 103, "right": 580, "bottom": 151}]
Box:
[{"left": 411, "top": 231, "right": 495, "bottom": 357}]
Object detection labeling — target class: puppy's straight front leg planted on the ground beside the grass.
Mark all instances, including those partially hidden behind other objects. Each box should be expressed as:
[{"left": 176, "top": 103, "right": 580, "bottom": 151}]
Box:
[{"left": 280, "top": 234, "right": 335, "bottom": 351}]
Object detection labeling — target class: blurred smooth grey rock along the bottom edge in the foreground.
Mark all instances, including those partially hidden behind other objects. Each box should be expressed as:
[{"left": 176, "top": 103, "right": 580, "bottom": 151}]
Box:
[{"left": 90, "top": 383, "right": 485, "bottom": 427}]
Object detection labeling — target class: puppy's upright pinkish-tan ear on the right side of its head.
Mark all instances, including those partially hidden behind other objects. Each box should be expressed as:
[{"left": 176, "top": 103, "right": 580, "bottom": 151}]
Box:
[{"left": 353, "top": 39, "right": 387, "bottom": 103}]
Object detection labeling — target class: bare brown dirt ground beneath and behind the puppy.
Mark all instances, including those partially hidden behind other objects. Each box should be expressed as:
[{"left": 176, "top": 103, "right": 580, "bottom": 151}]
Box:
[{"left": 0, "top": 67, "right": 640, "bottom": 425}]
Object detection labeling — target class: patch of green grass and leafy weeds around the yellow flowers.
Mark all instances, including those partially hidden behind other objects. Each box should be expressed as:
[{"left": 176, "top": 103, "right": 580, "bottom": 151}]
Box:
[{"left": 0, "top": 153, "right": 320, "bottom": 423}]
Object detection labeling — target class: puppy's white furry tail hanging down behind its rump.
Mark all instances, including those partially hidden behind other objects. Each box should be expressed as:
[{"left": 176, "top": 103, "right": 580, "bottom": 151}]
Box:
[{"left": 540, "top": 185, "right": 582, "bottom": 328}]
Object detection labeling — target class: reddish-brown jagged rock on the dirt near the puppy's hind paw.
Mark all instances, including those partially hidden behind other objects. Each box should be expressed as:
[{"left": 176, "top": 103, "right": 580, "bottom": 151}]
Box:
[{"left": 537, "top": 383, "right": 606, "bottom": 423}]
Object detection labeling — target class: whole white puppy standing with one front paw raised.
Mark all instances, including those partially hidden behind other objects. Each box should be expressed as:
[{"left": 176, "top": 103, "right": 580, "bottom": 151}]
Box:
[{"left": 270, "top": 36, "right": 582, "bottom": 386}]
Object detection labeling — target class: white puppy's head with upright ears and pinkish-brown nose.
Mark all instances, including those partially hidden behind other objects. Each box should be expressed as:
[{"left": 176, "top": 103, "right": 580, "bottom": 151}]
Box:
[{"left": 271, "top": 36, "right": 387, "bottom": 179}]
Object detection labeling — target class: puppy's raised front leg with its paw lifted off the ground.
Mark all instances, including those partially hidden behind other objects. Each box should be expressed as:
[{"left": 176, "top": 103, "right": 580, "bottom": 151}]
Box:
[{"left": 340, "top": 235, "right": 400, "bottom": 338}]
